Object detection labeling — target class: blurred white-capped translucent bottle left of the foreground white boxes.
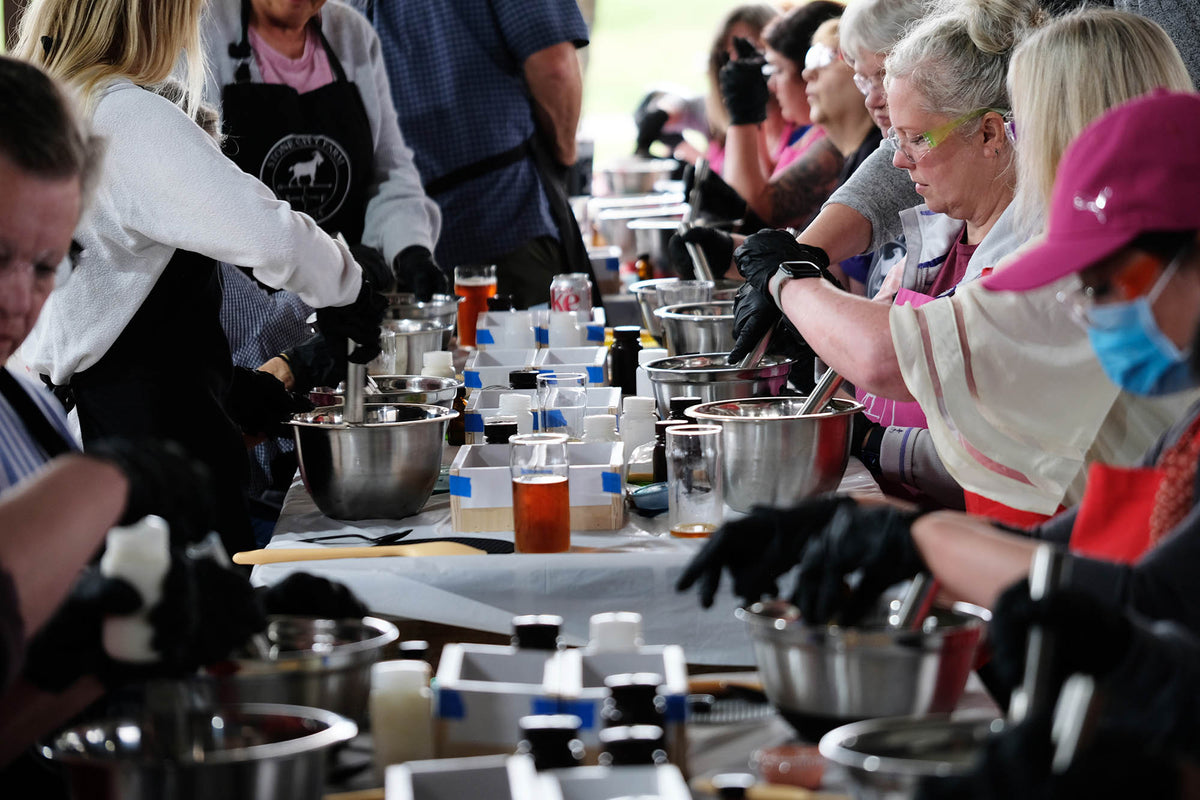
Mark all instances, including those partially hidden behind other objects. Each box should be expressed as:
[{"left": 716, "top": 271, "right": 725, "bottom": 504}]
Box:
[{"left": 368, "top": 661, "right": 433, "bottom": 777}]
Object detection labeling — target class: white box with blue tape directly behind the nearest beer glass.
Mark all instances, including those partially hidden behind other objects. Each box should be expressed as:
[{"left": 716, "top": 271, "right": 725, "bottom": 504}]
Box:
[{"left": 450, "top": 441, "right": 625, "bottom": 533}]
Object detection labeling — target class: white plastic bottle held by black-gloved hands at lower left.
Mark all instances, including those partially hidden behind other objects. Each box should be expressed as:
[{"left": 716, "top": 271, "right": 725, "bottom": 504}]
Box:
[{"left": 100, "top": 516, "right": 170, "bottom": 663}]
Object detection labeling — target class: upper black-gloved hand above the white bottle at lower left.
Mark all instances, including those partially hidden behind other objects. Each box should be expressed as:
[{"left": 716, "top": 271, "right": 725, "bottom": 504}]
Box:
[{"left": 85, "top": 439, "right": 216, "bottom": 547}]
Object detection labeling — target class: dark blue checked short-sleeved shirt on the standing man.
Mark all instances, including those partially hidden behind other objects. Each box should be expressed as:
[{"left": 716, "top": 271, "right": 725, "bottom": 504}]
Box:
[{"left": 352, "top": 0, "right": 588, "bottom": 266}]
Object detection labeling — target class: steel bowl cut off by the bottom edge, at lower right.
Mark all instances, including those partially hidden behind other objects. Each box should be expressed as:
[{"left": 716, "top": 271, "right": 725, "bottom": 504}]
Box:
[{"left": 821, "top": 716, "right": 1004, "bottom": 800}]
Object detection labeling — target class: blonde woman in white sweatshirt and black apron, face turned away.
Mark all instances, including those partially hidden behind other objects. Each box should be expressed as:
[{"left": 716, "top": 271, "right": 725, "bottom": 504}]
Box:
[{"left": 17, "top": 0, "right": 383, "bottom": 551}]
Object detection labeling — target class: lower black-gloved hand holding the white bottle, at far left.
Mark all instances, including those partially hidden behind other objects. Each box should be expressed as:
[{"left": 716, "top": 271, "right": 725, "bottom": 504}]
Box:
[{"left": 24, "top": 565, "right": 142, "bottom": 692}]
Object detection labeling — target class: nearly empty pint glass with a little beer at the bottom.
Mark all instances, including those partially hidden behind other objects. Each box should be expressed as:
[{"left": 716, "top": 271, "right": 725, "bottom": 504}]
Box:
[{"left": 666, "top": 425, "right": 725, "bottom": 539}]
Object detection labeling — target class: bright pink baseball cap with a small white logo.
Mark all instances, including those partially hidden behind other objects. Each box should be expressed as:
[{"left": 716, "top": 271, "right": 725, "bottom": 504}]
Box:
[{"left": 984, "top": 89, "right": 1200, "bottom": 291}]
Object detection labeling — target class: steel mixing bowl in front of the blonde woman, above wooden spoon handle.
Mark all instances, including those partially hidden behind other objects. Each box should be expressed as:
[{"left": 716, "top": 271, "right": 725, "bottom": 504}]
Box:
[{"left": 290, "top": 403, "right": 458, "bottom": 519}]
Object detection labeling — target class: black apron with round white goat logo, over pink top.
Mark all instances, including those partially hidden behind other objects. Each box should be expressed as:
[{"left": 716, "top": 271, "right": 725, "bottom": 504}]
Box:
[{"left": 221, "top": 0, "right": 374, "bottom": 245}]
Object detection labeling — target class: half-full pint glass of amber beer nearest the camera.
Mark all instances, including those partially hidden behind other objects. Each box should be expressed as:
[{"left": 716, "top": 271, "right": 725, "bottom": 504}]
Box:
[{"left": 509, "top": 433, "right": 571, "bottom": 553}]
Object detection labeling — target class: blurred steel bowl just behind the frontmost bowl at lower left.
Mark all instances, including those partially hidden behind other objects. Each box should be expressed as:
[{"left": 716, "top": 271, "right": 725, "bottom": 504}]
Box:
[{"left": 212, "top": 616, "right": 400, "bottom": 723}]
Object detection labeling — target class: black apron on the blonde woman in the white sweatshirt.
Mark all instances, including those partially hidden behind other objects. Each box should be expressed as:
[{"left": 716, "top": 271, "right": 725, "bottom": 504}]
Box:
[{"left": 70, "top": 251, "right": 254, "bottom": 553}]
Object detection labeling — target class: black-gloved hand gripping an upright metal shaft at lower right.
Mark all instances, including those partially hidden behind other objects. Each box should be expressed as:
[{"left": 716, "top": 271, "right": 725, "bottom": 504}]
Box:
[{"left": 989, "top": 578, "right": 1133, "bottom": 705}]
